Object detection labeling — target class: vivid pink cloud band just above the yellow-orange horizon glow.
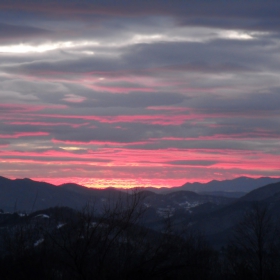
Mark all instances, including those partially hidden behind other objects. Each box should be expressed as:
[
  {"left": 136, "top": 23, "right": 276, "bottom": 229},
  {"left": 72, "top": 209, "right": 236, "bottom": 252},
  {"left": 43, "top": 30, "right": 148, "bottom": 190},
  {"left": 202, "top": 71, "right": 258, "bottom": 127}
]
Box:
[{"left": 0, "top": 148, "right": 280, "bottom": 170}]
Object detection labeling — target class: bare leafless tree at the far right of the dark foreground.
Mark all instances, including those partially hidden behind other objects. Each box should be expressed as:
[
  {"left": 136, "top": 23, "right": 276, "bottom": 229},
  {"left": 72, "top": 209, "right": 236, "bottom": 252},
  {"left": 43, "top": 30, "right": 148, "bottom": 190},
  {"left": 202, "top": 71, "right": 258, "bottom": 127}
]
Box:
[{"left": 224, "top": 203, "right": 275, "bottom": 280}]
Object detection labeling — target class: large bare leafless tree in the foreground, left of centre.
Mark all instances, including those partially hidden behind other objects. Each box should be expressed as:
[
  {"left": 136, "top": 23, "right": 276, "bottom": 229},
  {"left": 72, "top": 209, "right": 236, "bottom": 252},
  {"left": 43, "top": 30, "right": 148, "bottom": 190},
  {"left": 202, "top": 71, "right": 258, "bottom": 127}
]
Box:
[{"left": 42, "top": 189, "right": 148, "bottom": 280}]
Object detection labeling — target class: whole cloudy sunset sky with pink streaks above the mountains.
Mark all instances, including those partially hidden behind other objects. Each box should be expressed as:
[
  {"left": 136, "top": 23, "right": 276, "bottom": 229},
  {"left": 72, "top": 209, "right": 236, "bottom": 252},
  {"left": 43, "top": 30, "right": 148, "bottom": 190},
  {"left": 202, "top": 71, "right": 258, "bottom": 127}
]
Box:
[{"left": 0, "top": 0, "right": 280, "bottom": 188}]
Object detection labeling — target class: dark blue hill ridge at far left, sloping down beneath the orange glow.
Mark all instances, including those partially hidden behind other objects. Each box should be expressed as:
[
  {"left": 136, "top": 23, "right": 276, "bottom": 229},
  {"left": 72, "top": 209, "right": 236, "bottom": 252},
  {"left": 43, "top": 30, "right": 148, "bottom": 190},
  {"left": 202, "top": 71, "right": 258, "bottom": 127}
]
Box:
[{"left": 0, "top": 177, "right": 125, "bottom": 213}]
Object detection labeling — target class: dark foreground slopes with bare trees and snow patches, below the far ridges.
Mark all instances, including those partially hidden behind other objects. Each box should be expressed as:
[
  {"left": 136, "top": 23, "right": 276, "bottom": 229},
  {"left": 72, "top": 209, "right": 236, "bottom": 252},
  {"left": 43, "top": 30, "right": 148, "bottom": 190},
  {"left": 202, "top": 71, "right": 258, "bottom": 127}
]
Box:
[{"left": 0, "top": 179, "right": 280, "bottom": 280}]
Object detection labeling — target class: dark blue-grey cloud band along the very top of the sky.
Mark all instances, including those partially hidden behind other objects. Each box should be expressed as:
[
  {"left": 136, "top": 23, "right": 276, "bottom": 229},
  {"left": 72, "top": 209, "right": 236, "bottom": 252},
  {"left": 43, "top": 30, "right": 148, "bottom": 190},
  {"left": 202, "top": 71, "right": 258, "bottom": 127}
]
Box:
[{"left": 1, "top": 0, "right": 279, "bottom": 25}]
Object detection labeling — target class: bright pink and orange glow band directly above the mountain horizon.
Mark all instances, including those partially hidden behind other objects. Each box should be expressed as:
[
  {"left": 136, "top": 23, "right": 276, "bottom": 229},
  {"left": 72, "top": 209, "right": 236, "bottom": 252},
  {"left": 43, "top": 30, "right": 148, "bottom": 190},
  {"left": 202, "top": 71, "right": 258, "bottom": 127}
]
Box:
[{"left": 0, "top": 145, "right": 280, "bottom": 188}]
